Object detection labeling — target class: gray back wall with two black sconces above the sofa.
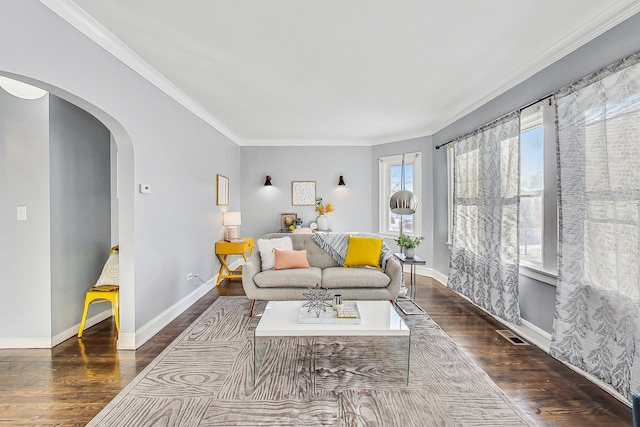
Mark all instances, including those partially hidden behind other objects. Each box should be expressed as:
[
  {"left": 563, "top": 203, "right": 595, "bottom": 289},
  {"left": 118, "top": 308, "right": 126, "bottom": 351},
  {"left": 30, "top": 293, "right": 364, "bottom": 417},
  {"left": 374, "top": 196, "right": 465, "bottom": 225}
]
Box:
[{"left": 240, "top": 147, "right": 370, "bottom": 241}]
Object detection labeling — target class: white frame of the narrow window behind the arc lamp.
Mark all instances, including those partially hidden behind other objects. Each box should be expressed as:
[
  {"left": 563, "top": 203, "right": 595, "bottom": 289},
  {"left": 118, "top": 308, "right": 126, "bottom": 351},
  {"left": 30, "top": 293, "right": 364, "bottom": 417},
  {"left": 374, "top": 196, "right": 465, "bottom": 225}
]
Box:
[{"left": 378, "top": 151, "right": 422, "bottom": 238}]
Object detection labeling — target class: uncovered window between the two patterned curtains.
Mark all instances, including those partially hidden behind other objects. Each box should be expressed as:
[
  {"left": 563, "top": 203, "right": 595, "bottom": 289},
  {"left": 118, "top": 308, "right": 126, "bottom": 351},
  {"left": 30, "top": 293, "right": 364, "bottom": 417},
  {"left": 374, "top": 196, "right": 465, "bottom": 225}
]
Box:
[{"left": 519, "top": 99, "right": 558, "bottom": 276}]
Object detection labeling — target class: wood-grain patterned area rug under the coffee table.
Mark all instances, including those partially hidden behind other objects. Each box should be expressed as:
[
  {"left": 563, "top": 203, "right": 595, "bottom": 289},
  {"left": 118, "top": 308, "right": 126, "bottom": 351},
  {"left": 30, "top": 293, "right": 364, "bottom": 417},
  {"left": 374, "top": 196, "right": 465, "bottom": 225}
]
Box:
[{"left": 89, "top": 297, "right": 533, "bottom": 426}]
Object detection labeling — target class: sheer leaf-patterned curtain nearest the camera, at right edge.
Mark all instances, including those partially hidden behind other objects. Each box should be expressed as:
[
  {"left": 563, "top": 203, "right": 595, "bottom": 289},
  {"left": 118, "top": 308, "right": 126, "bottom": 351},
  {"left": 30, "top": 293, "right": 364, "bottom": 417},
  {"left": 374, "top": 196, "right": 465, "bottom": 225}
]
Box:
[{"left": 551, "top": 54, "right": 640, "bottom": 399}]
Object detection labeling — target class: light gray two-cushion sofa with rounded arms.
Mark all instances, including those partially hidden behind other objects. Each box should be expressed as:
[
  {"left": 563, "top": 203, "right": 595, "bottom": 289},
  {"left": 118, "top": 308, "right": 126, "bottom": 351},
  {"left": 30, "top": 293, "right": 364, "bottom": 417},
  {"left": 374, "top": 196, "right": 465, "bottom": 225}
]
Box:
[{"left": 242, "top": 233, "right": 402, "bottom": 314}]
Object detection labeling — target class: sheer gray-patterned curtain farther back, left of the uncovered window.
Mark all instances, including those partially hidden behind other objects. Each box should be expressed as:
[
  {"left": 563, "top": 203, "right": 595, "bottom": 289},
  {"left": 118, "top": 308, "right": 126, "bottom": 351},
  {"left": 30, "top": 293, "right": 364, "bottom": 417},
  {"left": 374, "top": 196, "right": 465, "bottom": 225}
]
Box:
[{"left": 447, "top": 112, "right": 520, "bottom": 324}]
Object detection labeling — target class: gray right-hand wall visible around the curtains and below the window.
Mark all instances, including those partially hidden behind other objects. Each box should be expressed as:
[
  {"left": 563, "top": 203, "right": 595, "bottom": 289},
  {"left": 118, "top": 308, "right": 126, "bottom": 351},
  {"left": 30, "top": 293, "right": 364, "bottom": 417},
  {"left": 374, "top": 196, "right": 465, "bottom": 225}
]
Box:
[{"left": 433, "top": 10, "right": 640, "bottom": 332}]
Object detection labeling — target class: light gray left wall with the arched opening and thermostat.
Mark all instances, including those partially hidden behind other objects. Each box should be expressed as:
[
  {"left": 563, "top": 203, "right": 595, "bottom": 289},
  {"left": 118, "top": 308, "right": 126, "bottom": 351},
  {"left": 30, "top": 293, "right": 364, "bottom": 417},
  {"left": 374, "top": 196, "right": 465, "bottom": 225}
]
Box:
[{"left": 0, "top": 0, "right": 241, "bottom": 347}]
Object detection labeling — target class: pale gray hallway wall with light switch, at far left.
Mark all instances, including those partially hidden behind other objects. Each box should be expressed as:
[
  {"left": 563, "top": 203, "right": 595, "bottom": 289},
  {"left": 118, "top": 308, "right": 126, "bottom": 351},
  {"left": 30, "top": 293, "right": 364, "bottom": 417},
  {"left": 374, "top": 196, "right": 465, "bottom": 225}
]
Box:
[{"left": 0, "top": 88, "right": 51, "bottom": 345}]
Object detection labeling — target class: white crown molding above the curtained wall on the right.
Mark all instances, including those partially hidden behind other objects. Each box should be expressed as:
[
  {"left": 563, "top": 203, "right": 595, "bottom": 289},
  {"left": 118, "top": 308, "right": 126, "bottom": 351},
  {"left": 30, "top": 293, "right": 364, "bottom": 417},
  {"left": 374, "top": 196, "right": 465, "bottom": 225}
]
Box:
[{"left": 433, "top": 0, "right": 640, "bottom": 133}]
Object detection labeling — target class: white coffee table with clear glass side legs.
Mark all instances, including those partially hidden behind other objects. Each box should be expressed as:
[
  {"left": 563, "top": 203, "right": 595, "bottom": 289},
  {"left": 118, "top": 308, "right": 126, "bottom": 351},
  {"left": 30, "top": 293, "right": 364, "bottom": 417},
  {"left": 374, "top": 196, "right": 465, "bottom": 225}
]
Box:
[{"left": 253, "top": 301, "right": 411, "bottom": 384}]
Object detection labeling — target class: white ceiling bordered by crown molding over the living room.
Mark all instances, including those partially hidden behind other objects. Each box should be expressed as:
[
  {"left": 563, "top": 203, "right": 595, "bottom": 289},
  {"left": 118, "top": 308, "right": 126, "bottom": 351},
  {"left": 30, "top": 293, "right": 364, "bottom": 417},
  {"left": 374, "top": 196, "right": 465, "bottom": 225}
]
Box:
[{"left": 48, "top": 0, "right": 640, "bottom": 145}]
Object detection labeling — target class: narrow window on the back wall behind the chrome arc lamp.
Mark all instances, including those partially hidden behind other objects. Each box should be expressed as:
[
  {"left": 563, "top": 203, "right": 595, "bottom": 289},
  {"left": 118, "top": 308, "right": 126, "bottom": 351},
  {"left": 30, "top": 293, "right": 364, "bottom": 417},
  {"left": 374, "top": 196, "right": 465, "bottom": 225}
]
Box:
[{"left": 378, "top": 153, "right": 421, "bottom": 236}]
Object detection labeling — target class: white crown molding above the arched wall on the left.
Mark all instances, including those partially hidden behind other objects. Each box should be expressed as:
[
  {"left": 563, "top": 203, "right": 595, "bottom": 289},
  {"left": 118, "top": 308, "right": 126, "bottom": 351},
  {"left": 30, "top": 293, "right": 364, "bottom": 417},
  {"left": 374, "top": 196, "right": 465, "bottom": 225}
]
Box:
[{"left": 39, "top": 0, "right": 242, "bottom": 145}]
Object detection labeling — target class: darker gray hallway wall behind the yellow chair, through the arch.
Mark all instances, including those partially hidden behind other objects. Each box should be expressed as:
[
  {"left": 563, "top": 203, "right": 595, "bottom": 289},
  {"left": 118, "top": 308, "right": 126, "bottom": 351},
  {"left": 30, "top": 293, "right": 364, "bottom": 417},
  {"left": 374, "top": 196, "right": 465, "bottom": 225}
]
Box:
[{"left": 49, "top": 95, "right": 111, "bottom": 336}]
